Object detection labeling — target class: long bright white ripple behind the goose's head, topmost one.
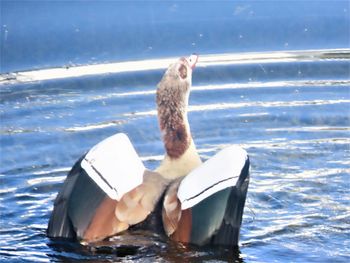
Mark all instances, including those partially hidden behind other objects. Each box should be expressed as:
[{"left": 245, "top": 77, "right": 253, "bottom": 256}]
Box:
[{"left": 0, "top": 49, "right": 350, "bottom": 84}]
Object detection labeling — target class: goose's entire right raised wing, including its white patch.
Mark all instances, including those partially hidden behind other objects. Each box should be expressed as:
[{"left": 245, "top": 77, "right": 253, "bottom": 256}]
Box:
[{"left": 163, "top": 147, "right": 249, "bottom": 246}]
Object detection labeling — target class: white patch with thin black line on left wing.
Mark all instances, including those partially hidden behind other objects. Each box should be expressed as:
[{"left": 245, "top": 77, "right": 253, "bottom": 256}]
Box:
[{"left": 81, "top": 133, "right": 145, "bottom": 201}]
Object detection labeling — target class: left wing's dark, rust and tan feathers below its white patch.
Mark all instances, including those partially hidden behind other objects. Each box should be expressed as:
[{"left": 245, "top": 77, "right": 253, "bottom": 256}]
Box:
[{"left": 47, "top": 163, "right": 167, "bottom": 245}]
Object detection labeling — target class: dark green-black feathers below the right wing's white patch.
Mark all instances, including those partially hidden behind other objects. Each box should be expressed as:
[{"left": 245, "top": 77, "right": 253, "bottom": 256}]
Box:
[{"left": 190, "top": 159, "right": 249, "bottom": 246}]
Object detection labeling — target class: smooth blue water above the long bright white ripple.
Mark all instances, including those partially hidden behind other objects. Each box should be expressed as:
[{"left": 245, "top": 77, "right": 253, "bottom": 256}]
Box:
[{"left": 0, "top": 0, "right": 350, "bottom": 72}]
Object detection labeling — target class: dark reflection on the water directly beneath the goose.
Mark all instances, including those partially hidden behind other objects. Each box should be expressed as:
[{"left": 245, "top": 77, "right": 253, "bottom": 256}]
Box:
[{"left": 48, "top": 231, "right": 243, "bottom": 262}]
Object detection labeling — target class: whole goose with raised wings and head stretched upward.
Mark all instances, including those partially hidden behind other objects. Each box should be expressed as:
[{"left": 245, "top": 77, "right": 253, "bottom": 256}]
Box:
[{"left": 47, "top": 54, "right": 250, "bottom": 249}]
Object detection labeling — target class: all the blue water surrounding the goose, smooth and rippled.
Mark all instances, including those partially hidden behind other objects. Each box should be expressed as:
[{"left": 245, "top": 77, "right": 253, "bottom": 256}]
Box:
[{"left": 0, "top": 1, "right": 350, "bottom": 262}]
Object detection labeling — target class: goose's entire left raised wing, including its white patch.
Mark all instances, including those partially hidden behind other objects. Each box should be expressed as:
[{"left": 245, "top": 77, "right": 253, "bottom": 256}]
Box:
[{"left": 47, "top": 134, "right": 166, "bottom": 242}]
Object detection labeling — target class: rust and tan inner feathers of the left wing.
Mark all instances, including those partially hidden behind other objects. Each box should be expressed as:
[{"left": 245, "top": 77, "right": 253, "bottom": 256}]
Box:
[{"left": 83, "top": 170, "right": 167, "bottom": 242}]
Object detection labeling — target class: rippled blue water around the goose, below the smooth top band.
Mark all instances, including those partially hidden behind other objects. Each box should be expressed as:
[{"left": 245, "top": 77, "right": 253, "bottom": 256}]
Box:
[{"left": 0, "top": 49, "right": 350, "bottom": 262}]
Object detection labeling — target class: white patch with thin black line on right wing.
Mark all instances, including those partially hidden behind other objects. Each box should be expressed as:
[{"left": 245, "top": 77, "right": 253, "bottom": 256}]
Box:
[{"left": 177, "top": 146, "right": 248, "bottom": 210}]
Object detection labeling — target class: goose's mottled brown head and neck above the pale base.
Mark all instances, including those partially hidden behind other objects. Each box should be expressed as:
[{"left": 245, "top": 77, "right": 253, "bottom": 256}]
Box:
[{"left": 157, "top": 63, "right": 191, "bottom": 159}]
